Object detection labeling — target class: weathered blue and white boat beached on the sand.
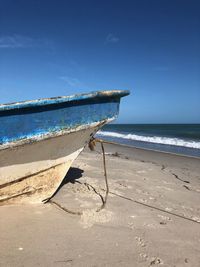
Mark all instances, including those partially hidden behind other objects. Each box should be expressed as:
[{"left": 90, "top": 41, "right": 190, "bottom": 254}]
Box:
[{"left": 0, "top": 90, "right": 129, "bottom": 203}]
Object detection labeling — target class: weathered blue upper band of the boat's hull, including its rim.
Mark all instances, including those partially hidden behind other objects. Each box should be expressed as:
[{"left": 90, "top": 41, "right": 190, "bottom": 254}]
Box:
[{"left": 0, "top": 91, "right": 128, "bottom": 147}]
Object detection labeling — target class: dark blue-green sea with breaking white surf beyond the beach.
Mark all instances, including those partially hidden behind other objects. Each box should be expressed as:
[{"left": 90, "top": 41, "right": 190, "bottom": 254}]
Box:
[{"left": 96, "top": 124, "right": 200, "bottom": 157}]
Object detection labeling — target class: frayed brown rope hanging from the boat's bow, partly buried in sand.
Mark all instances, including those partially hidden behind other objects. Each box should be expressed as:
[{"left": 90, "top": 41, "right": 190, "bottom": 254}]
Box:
[{"left": 48, "top": 138, "right": 109, "bottom": 215}]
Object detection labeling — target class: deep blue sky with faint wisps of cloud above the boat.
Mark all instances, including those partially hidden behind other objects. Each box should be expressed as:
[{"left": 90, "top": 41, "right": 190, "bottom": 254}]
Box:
[{"left": 0, "top": 0, "right": 200, "bottom": 123}]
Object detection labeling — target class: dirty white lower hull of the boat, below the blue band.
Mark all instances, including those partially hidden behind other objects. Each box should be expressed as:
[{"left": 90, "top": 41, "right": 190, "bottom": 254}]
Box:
[{"left": 0, "top": 124, "right": 99, "bottom": 204}]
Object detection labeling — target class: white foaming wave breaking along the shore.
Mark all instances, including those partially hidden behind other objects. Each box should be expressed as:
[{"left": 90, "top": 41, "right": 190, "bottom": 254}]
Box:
[{"left": 97, "top": 131, "right": 200, "bottom": 149}]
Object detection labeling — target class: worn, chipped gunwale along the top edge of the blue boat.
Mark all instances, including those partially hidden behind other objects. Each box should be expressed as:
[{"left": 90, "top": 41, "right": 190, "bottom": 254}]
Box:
[{"left": 0, "top": 90, "right": 130, "bottom": 112}]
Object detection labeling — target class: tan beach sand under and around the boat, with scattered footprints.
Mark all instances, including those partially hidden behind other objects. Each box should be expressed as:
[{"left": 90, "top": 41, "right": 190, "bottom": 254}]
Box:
[{"left": 0, "top": 144, "right": 200, "bottom": 267}]
